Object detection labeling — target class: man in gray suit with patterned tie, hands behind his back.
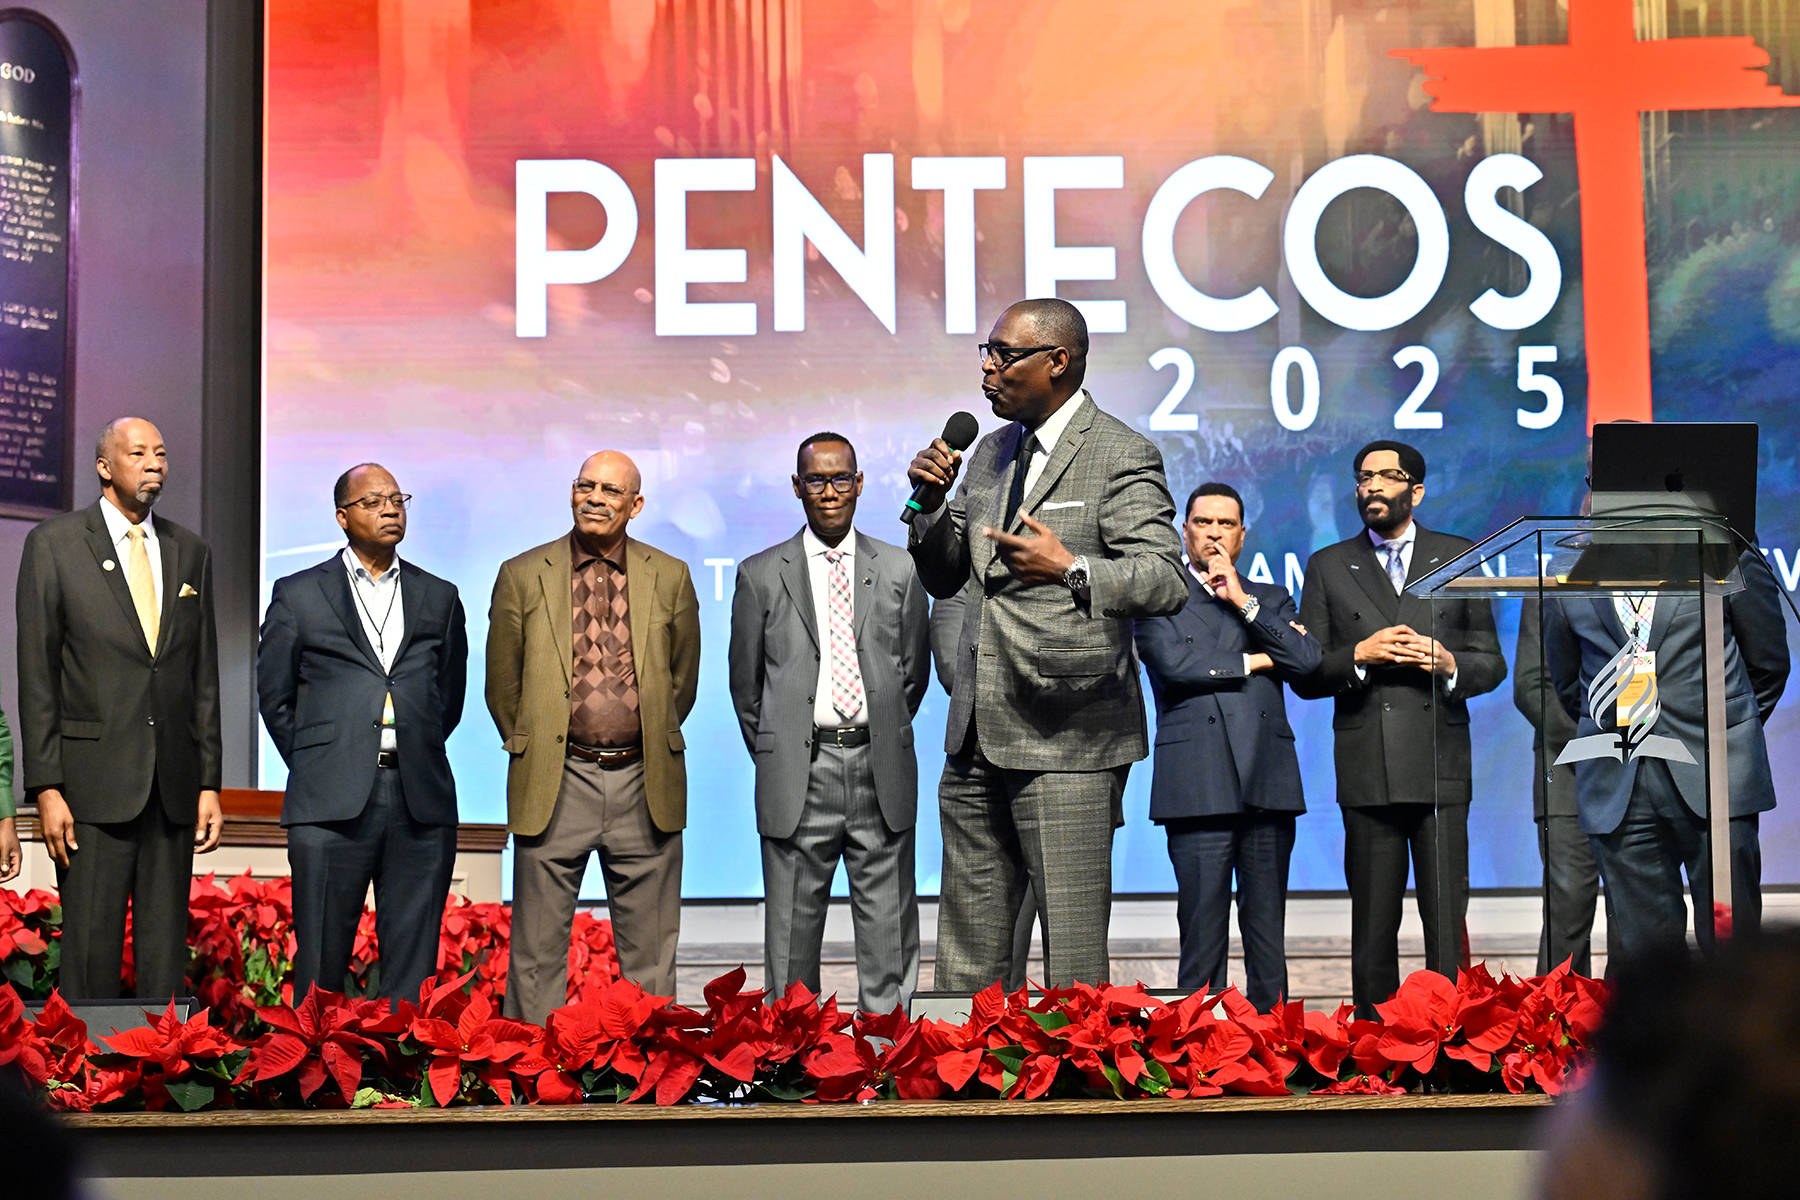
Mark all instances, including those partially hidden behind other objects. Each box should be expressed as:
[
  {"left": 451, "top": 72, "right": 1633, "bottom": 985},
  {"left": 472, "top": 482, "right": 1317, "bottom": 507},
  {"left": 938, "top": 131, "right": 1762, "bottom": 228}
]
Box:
[{"left": 731, "top": 434, "right": 931, "bottom": 1013}]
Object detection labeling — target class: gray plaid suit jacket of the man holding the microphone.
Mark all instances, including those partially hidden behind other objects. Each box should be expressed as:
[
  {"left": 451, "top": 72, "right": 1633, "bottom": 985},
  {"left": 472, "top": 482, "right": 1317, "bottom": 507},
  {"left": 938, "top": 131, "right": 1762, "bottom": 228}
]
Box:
[{"left": 909, "top": 389, "right": 1188, "bottom": 772}]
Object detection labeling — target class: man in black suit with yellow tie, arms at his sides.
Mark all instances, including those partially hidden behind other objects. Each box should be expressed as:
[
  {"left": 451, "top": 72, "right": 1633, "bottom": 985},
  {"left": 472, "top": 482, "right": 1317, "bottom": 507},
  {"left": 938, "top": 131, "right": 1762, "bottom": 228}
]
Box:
[{"left": 18, "top": 417, "right": 223, "bottom": 1000}]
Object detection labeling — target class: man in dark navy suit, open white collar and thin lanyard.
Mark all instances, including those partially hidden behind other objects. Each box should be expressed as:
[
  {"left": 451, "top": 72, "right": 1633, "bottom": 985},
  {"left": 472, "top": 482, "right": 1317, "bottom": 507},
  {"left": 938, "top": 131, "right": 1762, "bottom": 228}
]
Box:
[{"left": 256, "top": 462, "right": 468, "bottom": 1002}]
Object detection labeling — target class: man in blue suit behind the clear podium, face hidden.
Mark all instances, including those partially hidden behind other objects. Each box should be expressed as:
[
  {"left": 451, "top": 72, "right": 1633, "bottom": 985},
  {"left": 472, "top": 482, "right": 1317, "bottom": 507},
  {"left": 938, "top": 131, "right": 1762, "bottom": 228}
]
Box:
[{"left": 1544, "top": 551, "right": 1789, "bottom": 955}]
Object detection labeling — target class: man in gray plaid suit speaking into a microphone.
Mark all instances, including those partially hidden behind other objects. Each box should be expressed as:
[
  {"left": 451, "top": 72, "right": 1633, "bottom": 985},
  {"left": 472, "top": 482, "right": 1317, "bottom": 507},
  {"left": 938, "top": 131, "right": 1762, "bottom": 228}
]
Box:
[{"left": 909, "top": 299, "right": 1188, "bottom": 991}]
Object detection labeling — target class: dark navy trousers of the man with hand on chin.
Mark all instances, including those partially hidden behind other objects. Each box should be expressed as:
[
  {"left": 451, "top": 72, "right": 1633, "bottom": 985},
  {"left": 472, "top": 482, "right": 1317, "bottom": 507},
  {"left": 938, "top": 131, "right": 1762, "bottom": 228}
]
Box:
[{"left": 1163, "top": 808, "right": 1294, "bottom": 1013}]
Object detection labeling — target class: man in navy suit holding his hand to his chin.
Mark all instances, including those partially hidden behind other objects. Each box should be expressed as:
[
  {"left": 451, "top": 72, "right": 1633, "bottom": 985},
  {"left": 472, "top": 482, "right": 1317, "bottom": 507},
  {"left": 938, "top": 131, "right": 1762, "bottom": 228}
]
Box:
[{"left": 1138, "top": 484, "right": 1319, "bottom": 1011}]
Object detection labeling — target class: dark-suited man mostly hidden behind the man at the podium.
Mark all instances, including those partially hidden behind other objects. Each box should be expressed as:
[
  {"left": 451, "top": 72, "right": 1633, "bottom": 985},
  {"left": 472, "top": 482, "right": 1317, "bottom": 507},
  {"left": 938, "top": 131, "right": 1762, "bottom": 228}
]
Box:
[{"left": 1512, "top": 597, "right": 1611, "bottom": 975}]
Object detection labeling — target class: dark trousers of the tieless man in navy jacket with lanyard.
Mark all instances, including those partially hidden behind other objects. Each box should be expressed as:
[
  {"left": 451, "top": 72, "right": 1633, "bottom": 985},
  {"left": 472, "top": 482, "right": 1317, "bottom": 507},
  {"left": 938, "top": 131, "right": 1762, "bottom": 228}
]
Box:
[{"left": 288, "top": 766, "right": 461, "bottom": 1004}]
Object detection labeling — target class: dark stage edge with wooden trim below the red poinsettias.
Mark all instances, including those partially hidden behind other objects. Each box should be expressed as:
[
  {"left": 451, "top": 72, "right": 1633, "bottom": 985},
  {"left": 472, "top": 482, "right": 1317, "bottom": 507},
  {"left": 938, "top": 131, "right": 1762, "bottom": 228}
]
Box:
[{"left": 67, "top": 1094, "right": 1553, "bottom": 1178}]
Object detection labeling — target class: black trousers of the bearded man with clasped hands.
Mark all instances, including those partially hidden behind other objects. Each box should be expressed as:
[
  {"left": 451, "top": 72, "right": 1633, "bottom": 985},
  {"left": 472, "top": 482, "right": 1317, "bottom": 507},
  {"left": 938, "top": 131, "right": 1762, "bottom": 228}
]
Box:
[{"left": 1343, "top": 804, "right": 1469, "bottom": 1018}]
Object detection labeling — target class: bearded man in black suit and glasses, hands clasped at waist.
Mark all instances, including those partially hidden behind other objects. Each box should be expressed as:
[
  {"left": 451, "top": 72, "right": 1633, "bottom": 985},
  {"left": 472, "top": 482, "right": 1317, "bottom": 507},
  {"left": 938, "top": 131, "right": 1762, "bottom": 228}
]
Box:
[{"left": 1294, "top": 441, "right": 1507, "bottom": 1016}]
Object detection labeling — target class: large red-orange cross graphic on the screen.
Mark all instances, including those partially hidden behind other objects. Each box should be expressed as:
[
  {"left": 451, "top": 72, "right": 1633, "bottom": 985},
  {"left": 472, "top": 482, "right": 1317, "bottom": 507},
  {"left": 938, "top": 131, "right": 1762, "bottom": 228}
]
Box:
[{"left": 1390, "top": 0, "right": 1800, "bottom": 430}]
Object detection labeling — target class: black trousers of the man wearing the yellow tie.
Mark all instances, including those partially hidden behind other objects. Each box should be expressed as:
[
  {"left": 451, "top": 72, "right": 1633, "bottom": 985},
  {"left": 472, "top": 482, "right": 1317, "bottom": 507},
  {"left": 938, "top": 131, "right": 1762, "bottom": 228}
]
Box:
[{"left": 56, "top": 784, "right": 194, "bottom": 1000}]
